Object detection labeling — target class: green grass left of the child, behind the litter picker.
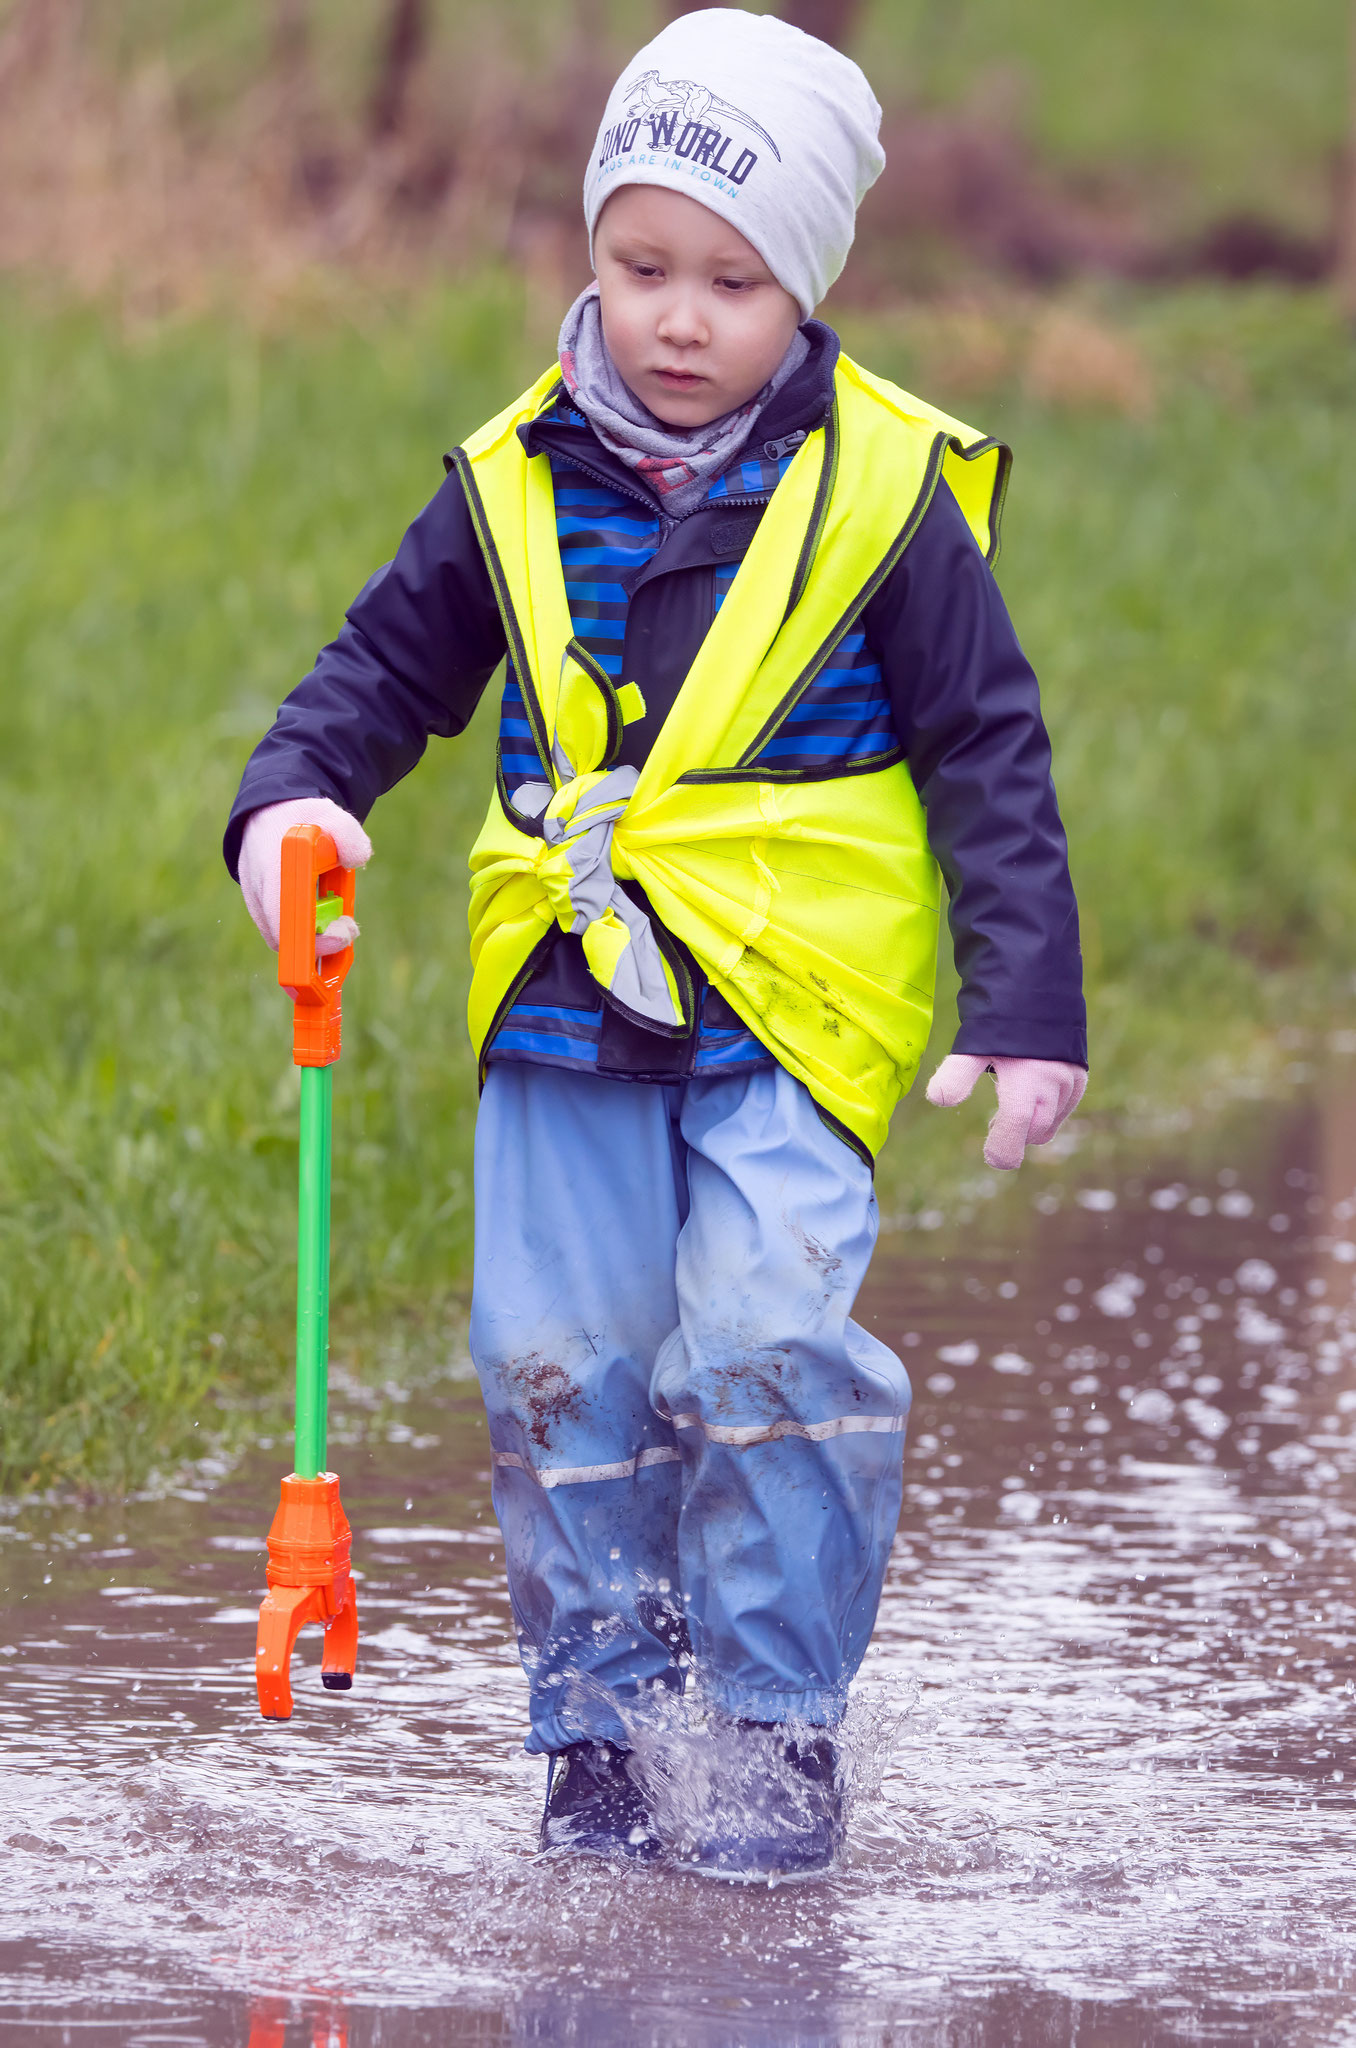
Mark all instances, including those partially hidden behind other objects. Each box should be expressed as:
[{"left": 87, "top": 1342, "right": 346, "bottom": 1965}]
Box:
[{"left": 0, "top": 280, "right": 520, "bottom": 1485}]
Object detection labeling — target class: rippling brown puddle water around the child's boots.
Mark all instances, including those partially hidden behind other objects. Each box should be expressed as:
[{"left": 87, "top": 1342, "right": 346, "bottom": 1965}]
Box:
[{"left": 0, "top": 1096, "right": 1356, "bottom": 2048}]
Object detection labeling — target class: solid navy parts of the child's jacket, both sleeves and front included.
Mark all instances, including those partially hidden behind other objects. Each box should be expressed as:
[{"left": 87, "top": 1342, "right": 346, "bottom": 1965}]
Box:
[{"left": 223, "top": 322, "right": 1088, "bottom": 1065}]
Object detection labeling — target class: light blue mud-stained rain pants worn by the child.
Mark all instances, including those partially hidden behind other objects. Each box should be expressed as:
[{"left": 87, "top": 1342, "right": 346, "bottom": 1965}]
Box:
[{"left": 471, "top": 1061, "right": 909, "bottom": 1751}]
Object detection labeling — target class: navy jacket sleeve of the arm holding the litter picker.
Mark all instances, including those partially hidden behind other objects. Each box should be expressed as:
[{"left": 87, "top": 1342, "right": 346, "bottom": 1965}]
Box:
[{"left": 223, "top": 473, "right": 504, "bottom": 877}]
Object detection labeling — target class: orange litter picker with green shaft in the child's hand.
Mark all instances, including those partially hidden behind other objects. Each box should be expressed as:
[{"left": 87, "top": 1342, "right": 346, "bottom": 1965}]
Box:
[{"left": 256, "top": 825, "right": 358, "bottom": 1720}]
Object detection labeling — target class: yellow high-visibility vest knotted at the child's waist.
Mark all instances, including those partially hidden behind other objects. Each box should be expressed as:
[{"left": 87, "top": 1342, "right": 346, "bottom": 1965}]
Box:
[{"left": 453, "top": 356, "right": 1010, "bottom": 1157}]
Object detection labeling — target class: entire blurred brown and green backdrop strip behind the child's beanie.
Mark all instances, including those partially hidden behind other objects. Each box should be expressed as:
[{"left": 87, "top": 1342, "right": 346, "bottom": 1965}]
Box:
[{"left": 0, "top": 0, "right": 1356, "bottom": 330}]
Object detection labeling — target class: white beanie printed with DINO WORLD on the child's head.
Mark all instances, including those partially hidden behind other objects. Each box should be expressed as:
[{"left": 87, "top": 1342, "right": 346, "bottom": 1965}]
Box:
[{"left": 584, "top": 6, "right": 885, "bottom": 319}]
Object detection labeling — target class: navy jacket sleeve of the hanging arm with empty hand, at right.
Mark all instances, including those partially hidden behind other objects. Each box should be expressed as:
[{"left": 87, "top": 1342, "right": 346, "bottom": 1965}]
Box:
[{"left": 864, "top": 483, "right": 1088, "bottom": 1067}]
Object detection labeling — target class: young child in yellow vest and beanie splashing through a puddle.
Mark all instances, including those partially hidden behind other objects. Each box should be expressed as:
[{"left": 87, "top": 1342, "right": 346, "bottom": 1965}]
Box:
[{"left": 225, "top": 8, "right": 1086, "bottom": 1878}]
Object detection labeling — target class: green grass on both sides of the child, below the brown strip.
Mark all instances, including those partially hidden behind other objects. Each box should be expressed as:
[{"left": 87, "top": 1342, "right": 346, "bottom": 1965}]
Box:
[{"left": 0, "top": 283, "right": 1356, "bottom": 1489}]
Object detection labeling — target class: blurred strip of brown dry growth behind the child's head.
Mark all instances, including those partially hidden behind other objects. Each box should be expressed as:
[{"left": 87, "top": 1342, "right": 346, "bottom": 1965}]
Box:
[{"left": 0, "top": 0, "right": 1331, "bottom": 335}]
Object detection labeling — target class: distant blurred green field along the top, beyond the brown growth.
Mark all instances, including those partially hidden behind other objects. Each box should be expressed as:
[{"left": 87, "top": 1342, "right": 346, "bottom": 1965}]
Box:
[{"left": 85, "top": 0, "right": 1350, "bottom": 225}]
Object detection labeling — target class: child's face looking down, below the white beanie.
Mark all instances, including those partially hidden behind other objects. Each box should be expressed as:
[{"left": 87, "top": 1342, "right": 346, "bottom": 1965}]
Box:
[{"left": 594, "top": 184, "right": 801, "bottom": 426}]
